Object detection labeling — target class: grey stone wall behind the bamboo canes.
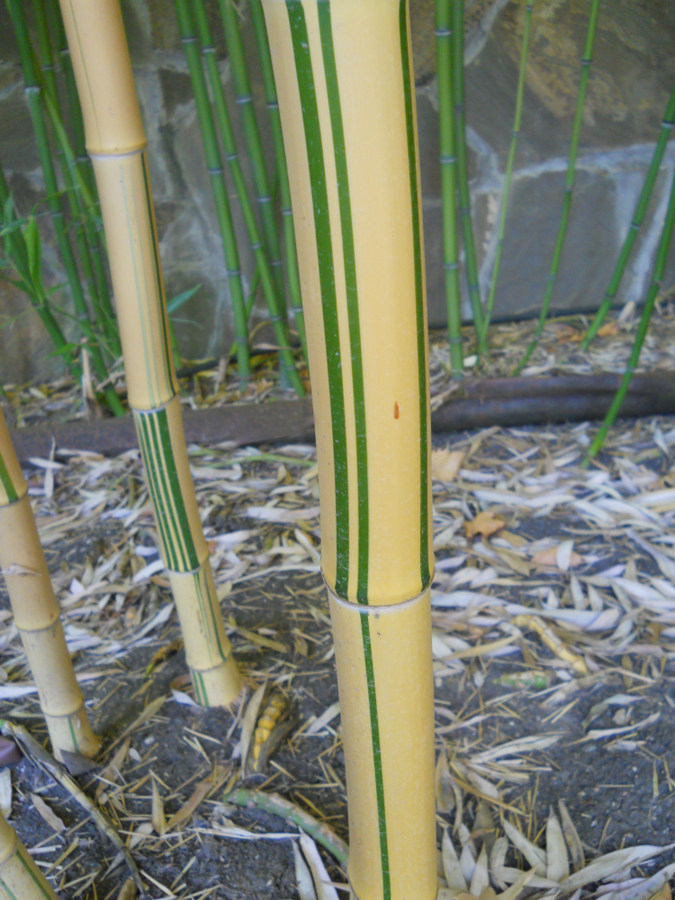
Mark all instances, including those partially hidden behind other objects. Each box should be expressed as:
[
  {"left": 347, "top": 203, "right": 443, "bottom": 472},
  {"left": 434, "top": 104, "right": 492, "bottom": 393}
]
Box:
[{"left": 0, "top": 0, "right": 675, "bottom": 381}]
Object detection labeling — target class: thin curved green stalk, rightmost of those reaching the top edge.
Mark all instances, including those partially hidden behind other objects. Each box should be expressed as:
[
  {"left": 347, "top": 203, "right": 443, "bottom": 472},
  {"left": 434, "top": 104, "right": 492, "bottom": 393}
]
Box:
[{"left": 513, "top": 0, "right": 600, "bottom": 375}]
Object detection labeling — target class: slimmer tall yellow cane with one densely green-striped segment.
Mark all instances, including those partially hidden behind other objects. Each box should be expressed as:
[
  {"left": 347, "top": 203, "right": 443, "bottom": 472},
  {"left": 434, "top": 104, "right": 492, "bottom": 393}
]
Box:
[{"left": 61, "top": 0, "right": 240, "bottom": 706}]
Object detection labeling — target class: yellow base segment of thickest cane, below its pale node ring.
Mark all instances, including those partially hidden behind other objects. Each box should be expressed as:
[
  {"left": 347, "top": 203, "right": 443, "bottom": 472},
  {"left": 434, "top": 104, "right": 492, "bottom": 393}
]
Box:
[{"left": 329, "top": 590, "right": 437, "bottom": 900}]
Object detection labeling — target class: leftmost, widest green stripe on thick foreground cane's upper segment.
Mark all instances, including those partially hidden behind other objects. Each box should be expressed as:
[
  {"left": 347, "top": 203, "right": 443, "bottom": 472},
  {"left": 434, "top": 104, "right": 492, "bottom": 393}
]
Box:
[{"left": 286, "top": 0, "right": 349, "bottom": 596}]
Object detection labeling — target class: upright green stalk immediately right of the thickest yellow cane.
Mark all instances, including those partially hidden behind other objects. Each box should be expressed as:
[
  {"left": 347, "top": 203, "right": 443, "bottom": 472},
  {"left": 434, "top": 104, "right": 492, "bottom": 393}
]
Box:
[{"left": 436, "top": 0, "right": 464, "bottom": 378}]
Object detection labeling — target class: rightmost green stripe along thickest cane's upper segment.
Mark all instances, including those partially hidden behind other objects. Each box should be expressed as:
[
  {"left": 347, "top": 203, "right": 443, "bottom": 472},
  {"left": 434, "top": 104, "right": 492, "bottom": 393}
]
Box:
[{"left": 399, "top": 0, "right": 431, "bottom": 589}]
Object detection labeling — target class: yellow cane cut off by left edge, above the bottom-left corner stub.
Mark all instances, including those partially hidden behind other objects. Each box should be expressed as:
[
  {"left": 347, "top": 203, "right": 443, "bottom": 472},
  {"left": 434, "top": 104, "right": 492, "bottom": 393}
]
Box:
[{"left": 0, "top": 410, "right": 98, "bottom": 759}]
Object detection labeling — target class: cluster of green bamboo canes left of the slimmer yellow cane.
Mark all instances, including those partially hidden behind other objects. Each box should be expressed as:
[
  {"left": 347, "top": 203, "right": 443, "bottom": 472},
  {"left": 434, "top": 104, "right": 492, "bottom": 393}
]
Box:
[{"left": 3, "top": 0, "right": 123, "bottom": 415}]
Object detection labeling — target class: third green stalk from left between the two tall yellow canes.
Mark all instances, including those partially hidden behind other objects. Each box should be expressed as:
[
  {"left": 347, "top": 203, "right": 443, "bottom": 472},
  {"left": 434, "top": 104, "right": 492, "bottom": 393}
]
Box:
[{"left": 218, "top": 0, "right": 284, "bottom": 297}]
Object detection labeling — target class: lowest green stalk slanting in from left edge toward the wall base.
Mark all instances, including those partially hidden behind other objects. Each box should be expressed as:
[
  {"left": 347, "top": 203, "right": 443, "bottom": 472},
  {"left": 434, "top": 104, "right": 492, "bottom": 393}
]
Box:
[{"left": 0, "top": 167, "right": 82, "bottom": 382}]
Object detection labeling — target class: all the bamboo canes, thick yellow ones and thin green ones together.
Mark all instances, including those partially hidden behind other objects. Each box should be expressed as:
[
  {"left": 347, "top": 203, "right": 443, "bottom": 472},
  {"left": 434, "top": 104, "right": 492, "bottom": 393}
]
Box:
[{"left": 0, "top": 0, "right": 675, "bottom": 900}]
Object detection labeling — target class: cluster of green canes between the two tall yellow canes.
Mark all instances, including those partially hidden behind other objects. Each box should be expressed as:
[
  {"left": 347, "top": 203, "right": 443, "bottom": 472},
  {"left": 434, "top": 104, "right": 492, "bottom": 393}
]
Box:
[{"left": 176, "top": 0, "right": 304, "bottom": 395}]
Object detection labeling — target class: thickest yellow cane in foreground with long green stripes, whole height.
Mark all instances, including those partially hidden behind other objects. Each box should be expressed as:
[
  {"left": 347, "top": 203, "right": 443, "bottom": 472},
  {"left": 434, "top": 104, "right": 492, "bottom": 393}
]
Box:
[{"left": 263, "top": 0, "right": 437, "bottom": 900}]
